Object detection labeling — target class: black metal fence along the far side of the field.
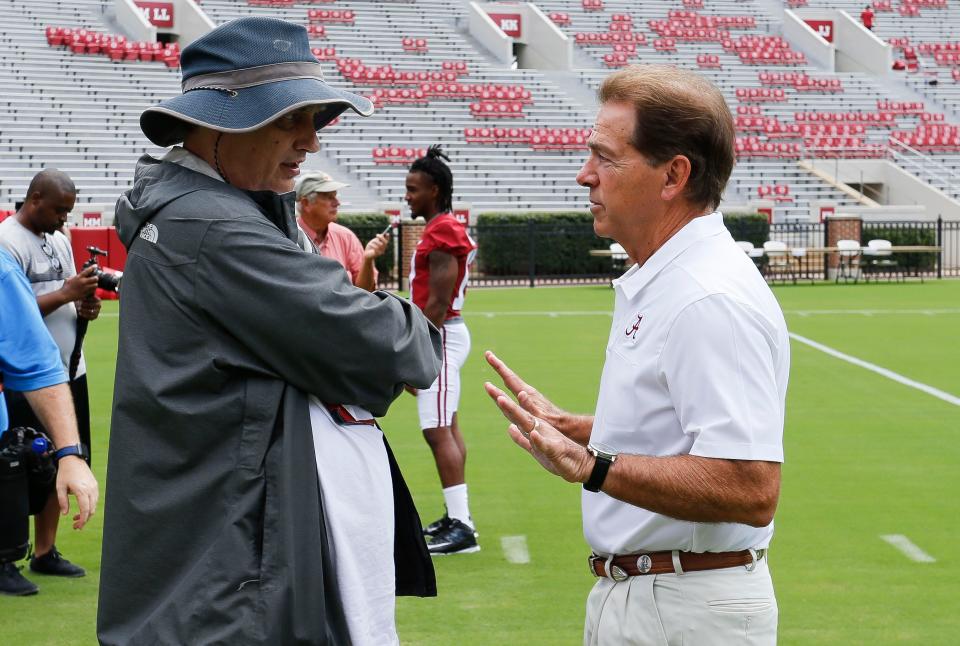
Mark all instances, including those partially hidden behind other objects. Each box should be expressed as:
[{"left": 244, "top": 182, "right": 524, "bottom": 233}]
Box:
[{"left": 350, "top": 217, "right": 960, "bottom": 289}]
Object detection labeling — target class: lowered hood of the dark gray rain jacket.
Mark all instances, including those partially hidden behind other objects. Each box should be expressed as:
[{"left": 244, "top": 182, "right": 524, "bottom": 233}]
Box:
[{"left": 114, "top": 155, "right": 297, "bottom": 250}]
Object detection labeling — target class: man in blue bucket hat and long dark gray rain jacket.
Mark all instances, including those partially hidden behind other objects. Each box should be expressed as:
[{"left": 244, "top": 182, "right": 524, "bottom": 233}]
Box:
[{"left": 97, "top": 18, "right": 440, "bottom": 644}]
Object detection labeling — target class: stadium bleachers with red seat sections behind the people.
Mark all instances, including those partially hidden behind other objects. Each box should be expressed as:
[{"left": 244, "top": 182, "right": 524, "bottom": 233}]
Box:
[{"left": 0, "top": 0, "right": 960, "bottom": 220}]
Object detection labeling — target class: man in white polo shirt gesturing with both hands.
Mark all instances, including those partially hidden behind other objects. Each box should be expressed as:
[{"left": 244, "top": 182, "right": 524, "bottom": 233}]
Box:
[{"left": 486, "top": 65, "right": 790, "bottom": 645}]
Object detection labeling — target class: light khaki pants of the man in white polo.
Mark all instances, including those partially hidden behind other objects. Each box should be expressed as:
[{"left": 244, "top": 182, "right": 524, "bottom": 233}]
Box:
[{"left": 583, "top": 558, "right": 778, "bottom": 646}]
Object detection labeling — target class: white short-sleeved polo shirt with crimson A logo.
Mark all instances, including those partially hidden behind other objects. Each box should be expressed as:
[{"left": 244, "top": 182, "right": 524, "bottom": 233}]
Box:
[{"left": 582, "top": 213, "right": 790, "bottom": 555}]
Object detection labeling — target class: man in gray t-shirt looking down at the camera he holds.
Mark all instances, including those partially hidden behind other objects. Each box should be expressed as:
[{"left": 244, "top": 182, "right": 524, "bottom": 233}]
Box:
[{"left": 0, "top": 169, "right": 100, "bottom": 577}]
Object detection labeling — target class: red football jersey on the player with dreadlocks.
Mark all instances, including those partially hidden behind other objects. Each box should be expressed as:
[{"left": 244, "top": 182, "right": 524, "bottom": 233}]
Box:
[{"left": 410, "top": 213, "right": 477, "bottom": 319}]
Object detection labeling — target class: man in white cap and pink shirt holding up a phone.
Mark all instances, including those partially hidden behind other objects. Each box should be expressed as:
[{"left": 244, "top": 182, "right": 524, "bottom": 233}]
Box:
[{"left": 297, "top": 172, "right": 389, "bottom": 292}]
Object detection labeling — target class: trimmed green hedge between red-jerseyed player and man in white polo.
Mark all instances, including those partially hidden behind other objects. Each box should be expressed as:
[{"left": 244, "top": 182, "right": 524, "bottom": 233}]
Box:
[{"left": 474, "top": 211, "right": 611, "bottom": 276}]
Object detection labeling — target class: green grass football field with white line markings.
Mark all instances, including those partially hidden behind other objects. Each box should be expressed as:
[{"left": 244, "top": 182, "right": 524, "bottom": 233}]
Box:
[{"left": 0, "top": 281, "right": 960, "bottom": 646}]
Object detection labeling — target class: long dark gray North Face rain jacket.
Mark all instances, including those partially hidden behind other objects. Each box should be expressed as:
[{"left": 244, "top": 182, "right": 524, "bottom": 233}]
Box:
[{"left": 97, "top": 156, "right": 441, "bottom": 646}]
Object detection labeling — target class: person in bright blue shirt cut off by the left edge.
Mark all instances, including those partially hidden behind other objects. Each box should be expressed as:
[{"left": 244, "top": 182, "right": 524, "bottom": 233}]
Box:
[{"left": 0, "top": 249, "right": 99, "bottom": 595}]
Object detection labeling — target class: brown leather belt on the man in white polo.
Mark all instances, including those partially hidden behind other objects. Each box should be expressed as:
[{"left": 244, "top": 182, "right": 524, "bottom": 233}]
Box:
[{"left": 587, "top": 550, "right": 766, "bottom": 581}]
